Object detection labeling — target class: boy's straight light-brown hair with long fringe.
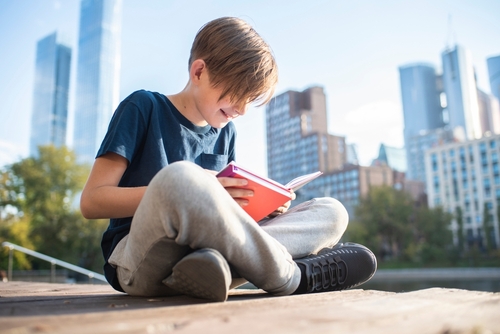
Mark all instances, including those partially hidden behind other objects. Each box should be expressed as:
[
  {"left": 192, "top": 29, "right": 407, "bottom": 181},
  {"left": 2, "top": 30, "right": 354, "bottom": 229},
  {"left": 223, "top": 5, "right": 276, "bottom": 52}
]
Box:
[{"left": 189, "top": 17, "right": 278, "bottom": 105}]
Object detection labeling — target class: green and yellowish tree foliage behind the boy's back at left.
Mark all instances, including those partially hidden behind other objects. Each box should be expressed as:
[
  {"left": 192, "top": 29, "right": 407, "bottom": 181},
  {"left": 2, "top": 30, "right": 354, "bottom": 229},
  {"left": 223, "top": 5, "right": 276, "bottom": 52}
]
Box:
[{"left": 0, "top": 146, "right": 106, "bottom": 271}]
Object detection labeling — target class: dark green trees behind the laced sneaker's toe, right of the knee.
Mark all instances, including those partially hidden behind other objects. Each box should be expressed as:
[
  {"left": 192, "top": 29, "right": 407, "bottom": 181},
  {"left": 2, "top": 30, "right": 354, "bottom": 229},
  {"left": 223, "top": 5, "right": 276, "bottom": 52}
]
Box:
[{"left": 347, "top": 186, "right": 452, "bottom": 266}]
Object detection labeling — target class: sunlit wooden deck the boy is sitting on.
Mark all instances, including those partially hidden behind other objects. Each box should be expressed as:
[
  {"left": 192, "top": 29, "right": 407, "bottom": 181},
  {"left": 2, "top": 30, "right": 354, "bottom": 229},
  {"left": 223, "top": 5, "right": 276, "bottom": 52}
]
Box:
[{"left": 0, "top": 282, "right": 500, "bottom": 334}]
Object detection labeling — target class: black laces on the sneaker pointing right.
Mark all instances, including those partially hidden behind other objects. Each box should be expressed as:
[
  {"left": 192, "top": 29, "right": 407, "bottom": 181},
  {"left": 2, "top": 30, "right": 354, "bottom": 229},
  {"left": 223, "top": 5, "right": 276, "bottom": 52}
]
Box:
[{"left": 311, "top": 256, "right": 348, "bottom": 291}]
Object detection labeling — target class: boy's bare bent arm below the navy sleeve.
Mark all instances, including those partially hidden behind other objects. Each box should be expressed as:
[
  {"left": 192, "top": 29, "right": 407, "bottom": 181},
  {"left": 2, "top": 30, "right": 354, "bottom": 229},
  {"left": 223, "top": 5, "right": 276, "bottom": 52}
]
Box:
[{"left": 80, "top": 153, "right": 146, "bottom": 219}]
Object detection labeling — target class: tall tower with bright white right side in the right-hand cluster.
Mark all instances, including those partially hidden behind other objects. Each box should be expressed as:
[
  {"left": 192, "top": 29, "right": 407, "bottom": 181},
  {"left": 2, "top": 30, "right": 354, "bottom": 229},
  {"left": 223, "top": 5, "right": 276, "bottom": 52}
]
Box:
[{"left": 441, "top": 45, "right": 482, "bottom": 139}]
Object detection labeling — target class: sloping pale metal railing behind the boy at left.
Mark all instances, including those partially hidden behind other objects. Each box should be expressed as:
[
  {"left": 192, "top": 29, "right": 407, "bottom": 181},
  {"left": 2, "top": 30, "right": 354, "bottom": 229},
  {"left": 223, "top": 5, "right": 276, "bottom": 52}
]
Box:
[{"left": 2, "top": 241, "right": 107, "bottom": 283}]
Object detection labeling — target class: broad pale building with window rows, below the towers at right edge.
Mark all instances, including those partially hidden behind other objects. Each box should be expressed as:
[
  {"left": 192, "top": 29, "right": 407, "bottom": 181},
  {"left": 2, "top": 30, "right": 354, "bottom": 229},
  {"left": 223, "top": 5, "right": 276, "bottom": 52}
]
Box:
[{"left": 425, "top": 135, "right": 500, "bottom": 248}]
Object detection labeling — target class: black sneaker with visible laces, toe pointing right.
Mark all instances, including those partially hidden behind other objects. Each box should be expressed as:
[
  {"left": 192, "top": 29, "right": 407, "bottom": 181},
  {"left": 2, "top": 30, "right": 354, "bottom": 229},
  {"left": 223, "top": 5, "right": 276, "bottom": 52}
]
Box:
[{"left": 294, "top": 242, "right": 377, "bottom": 294}]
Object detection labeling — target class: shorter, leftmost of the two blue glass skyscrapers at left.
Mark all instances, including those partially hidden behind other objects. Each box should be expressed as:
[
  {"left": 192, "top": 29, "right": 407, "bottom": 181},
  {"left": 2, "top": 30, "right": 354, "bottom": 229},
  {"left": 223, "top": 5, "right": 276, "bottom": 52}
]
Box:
[{"left": 30, "top": 32, "right": 71, "bottom": 156}]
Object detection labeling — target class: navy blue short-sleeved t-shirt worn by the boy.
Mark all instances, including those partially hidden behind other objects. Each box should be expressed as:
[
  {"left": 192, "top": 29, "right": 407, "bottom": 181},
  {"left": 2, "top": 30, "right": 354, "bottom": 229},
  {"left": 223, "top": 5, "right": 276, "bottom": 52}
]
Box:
[{"left": 97, "top": 90, "right": 236, "bottom": 291}]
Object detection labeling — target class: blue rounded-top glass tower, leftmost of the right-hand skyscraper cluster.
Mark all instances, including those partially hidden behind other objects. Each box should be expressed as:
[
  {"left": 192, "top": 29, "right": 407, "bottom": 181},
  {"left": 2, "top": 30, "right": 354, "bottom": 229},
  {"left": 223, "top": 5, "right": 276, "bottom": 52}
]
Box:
[{"left": 399, "top": 63, "right": 445, "bottom": 182}]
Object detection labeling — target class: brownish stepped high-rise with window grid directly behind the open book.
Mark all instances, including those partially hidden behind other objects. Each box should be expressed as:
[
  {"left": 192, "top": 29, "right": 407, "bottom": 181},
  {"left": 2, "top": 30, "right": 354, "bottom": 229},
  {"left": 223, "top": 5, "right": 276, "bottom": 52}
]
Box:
[{"left": 266, "top": 87, "right": 347, "bottom": 183}]
